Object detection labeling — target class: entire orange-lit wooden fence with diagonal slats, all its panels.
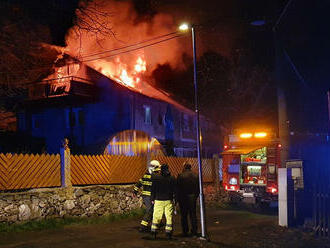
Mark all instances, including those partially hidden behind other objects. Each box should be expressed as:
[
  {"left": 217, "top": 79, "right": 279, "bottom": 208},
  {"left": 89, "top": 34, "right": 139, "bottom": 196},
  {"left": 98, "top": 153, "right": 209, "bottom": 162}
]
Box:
[{"left": 0, "top": 154, "right": 216, "bottom": 190}]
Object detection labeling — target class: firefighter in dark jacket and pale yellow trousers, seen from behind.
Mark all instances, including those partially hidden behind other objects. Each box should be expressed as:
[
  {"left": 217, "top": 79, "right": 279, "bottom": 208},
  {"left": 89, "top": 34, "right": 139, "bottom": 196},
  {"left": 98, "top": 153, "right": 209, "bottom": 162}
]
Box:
[{"left": 151, "top": 164, "right": 176, "bottom": 239}]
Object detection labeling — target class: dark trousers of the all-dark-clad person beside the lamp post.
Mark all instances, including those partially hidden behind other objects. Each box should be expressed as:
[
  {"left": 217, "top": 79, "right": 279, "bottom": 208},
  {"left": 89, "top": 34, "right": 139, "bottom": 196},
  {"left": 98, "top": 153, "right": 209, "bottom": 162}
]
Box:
[{"left": 179, "top": 195, "right": 197, "bottom": 234}]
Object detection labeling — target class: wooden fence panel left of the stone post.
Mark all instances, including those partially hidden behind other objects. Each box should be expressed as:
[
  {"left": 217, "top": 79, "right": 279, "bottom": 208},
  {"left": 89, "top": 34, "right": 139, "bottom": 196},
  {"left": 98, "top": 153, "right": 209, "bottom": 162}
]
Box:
[{"left": 0, "top": 153, "right": 61, "bottom": 190}]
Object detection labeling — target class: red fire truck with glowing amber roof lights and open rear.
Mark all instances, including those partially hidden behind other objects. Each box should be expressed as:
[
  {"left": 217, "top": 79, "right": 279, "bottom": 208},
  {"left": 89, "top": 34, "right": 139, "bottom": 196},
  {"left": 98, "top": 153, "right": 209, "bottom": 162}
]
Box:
[{"left": 222, "top": 129, "right": 281, "bottom": 202}]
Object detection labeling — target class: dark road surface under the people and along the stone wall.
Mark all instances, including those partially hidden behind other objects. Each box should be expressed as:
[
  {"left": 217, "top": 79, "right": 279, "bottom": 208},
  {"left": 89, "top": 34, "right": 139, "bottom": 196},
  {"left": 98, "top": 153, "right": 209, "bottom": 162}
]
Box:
[{"left": 0, "top": 209, "right": 330, "bottom": 248}]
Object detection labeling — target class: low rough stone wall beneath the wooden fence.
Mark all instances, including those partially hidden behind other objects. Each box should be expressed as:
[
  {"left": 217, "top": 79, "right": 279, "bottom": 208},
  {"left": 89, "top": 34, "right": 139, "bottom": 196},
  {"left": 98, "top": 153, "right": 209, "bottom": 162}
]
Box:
[{"left": 0, "top": 185, "right": 142, "bottom": 223}]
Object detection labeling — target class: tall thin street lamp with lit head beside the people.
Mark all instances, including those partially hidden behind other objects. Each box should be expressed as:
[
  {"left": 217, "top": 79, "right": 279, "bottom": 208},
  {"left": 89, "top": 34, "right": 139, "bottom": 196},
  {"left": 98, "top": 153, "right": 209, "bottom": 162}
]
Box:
[{"left": 179, "top": 23, "right": 206, "bottom": 239}]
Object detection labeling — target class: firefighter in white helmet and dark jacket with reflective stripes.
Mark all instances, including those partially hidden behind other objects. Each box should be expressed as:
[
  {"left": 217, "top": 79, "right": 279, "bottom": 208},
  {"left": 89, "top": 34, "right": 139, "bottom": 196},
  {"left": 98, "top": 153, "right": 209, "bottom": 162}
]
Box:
[{"left": 134, "top": 160, "right": 160, "bottom": 232}]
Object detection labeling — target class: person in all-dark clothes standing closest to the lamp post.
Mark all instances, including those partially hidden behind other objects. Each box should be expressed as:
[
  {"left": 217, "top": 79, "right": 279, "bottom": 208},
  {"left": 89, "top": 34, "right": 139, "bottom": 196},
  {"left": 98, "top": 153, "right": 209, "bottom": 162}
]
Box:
[{"left": 177, "top": 164, "right": 199, "bottom": 236}]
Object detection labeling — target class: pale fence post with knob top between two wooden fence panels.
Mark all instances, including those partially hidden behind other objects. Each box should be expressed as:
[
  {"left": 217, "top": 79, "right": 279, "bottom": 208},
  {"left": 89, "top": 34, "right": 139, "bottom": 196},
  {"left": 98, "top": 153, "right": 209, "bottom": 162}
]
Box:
[{"left": 60, "top": 139, "right": 72, "bottom": 188}]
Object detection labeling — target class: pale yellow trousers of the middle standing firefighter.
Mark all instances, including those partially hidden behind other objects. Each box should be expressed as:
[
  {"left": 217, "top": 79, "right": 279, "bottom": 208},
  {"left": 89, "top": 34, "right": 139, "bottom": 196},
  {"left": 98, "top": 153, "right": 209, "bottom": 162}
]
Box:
[{"left": 151, "top": 200, "right": 173, "bottom": 232}]
